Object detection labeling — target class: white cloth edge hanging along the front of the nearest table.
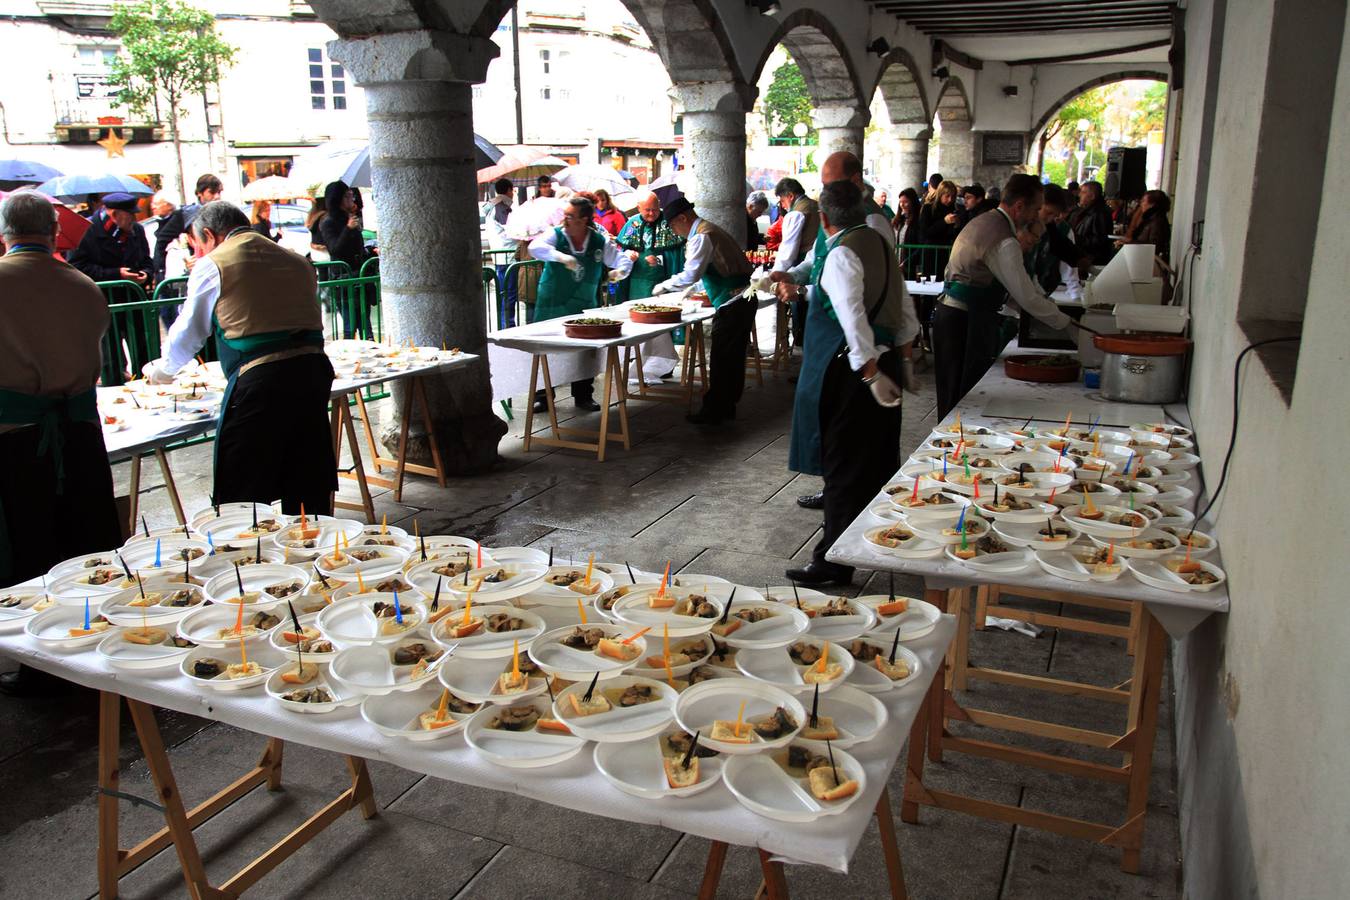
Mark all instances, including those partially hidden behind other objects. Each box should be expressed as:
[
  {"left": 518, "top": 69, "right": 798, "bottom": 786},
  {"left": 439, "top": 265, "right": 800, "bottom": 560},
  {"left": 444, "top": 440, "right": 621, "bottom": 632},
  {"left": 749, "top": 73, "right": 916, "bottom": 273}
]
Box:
[{"left": 0, "top": 615, "right": 956, "bottom": 872}]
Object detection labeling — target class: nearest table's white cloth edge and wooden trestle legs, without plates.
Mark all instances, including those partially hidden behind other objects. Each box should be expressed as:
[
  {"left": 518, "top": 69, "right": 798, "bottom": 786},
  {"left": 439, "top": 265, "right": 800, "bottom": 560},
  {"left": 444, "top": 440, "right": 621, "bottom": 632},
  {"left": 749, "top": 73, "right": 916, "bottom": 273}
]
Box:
[{"left": 0, "top": 593, "right": 956, "bottom": 899}]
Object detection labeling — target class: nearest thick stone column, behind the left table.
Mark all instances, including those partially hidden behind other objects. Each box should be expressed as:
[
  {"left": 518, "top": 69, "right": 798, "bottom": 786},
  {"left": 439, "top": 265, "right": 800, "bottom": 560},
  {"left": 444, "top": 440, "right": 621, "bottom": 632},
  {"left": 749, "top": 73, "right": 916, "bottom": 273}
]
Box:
[{"left": 328, "top": 31, "right": 506, "bottom": 474}]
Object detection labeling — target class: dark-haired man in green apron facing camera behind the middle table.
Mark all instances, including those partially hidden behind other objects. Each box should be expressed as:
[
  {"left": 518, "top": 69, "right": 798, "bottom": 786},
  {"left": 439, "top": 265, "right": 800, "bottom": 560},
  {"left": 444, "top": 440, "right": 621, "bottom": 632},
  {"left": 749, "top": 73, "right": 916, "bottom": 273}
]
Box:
[{"left": 529, "top": 197, "right": 633, "bottom": 413}]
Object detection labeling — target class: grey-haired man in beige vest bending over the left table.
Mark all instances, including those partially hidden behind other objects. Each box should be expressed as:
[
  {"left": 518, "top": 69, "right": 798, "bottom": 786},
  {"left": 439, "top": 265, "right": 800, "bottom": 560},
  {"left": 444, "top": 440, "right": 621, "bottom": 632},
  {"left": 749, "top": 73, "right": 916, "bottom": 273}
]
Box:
[{"left": 146, "top": 200, "right": 338, "bottom": 514}]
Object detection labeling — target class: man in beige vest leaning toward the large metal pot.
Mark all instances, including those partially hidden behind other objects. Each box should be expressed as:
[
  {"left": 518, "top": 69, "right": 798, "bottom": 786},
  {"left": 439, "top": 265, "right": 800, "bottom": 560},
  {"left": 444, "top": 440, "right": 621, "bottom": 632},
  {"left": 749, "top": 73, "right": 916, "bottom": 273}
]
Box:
[{"left": 933, "top": 174, "right": 1077, "bottom": 418}]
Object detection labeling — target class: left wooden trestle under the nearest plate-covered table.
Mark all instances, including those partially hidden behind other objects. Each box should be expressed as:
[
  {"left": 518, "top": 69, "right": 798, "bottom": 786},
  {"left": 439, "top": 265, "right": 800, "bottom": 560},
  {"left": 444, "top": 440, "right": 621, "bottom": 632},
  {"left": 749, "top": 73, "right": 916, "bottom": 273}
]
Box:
[{"left": 99, "top": 691, "right": 378, "bottom": 900}]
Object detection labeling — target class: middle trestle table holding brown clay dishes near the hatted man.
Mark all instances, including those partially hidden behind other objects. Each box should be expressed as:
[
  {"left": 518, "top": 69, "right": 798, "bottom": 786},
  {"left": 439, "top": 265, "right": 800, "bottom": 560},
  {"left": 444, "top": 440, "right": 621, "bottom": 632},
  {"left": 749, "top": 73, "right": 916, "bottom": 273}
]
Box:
[{"left": 487, "top": 308, "right": 716, "bottom": 463}]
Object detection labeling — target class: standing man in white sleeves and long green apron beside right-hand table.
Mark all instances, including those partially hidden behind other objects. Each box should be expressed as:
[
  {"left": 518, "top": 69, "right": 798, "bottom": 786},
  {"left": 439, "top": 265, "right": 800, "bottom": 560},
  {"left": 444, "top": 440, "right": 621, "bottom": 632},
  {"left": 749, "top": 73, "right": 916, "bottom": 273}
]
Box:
[{"left": 787, "top": 181, "right": 919, "bottom": 586}]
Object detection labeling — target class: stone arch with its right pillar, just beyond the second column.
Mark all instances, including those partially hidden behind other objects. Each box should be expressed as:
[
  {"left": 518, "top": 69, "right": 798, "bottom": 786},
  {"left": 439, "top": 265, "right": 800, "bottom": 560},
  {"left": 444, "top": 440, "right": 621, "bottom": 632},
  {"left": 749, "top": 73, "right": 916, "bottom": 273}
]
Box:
[{"left": 753, "top": 9, "right": 871, "bottom": 159}]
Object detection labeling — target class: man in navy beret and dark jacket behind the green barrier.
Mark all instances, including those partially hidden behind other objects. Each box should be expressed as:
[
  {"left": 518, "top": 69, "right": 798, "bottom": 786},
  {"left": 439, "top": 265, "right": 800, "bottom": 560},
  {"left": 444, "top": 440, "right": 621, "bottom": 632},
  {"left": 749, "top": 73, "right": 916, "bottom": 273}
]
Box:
[{"left": 70, "top": 192, "right": 154, "bottom": 375}]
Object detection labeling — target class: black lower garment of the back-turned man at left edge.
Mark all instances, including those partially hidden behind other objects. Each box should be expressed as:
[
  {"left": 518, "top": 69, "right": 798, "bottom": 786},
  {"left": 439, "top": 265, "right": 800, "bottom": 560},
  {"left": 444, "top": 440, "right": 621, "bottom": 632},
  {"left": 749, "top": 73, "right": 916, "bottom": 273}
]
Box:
[{"left": 0, "top": 422, "right": 122, "bottom": 584}]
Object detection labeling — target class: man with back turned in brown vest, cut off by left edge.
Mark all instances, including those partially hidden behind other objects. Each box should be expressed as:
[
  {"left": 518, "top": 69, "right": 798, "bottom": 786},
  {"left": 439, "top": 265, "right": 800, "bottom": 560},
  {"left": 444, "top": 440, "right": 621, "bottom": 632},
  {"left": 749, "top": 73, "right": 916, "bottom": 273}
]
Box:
[{"left": 0, "top": 190, "right": 122, "bottom": 694}]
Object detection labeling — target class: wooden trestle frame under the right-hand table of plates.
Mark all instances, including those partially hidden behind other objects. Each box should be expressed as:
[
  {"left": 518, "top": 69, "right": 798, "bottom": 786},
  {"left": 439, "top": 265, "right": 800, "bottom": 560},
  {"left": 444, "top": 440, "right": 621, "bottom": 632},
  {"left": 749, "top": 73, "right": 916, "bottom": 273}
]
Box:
[{"left": 900, "top": 586, "right": 1166, "bottom": 874}]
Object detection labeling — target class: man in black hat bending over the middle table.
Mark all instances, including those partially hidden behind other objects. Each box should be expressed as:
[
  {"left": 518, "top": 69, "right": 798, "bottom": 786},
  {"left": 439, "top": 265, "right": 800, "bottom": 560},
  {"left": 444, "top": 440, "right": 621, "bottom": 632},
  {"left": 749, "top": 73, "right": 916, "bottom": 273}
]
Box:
[{"left": 652, "top": 197, "right": 756, "bottom": 425}]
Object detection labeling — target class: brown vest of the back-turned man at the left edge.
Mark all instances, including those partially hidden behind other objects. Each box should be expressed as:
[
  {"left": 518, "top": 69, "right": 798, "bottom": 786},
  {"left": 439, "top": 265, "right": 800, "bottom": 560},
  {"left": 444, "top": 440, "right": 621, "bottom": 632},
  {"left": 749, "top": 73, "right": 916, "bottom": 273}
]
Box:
[{"left": 0, "top": 252, "right": 108, "bottom": 396}]
